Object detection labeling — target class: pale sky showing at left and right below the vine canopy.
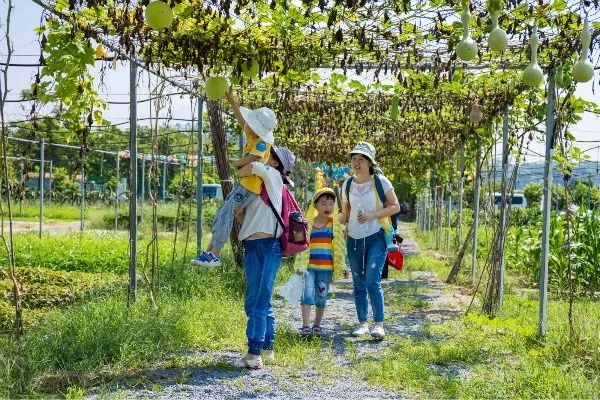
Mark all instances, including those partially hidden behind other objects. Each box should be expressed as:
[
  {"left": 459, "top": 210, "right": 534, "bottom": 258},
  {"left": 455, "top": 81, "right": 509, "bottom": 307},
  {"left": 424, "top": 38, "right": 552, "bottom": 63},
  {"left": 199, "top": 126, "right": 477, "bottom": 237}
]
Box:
[{"left": 0, "top": 0, "right": 600, "bottom": 162}]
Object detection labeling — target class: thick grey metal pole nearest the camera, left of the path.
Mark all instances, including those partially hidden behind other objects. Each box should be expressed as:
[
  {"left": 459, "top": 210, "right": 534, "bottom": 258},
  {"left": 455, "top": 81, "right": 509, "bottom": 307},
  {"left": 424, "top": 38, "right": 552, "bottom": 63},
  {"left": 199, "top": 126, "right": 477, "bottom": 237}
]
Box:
[{"left": 129, "top": 53, "right": 137, "bottom": 301}]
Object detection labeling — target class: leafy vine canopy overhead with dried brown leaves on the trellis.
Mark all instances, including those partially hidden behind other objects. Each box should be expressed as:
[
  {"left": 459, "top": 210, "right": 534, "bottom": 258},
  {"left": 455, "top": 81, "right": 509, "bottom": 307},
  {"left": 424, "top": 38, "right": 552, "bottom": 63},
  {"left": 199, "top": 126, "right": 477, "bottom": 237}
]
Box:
[{"left": 39, "top": 0, "right": 600, "bottom": 173}]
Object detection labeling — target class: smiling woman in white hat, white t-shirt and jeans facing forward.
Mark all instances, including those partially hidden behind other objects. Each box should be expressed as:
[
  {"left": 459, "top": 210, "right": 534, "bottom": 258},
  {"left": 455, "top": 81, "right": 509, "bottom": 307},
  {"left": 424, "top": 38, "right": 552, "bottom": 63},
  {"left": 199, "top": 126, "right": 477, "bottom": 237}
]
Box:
[{"left": 339, "top": 142, "right": 400, "bottom": 339}]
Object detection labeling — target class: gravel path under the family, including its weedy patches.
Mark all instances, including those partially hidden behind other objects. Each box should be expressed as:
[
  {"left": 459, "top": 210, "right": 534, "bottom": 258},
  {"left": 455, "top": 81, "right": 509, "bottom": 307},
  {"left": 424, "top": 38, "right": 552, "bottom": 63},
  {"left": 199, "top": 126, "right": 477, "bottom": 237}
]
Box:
[{"left": 88, "top": 232, "right": 470, "bottom": 399}]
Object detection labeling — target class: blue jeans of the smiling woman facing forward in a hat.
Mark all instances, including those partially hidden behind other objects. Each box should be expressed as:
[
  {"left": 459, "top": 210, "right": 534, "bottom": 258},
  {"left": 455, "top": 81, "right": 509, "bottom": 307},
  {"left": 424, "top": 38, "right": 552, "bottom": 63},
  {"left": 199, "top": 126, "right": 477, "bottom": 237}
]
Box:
[{"left": 346, "top": 230, "right": 387, "bottom": 323}]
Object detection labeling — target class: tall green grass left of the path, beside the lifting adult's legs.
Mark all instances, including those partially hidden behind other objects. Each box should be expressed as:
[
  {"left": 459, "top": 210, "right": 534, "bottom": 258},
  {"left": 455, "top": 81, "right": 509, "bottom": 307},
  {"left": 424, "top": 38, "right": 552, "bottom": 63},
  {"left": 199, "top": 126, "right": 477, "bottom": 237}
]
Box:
[{"left": 0, "top": 266, "right": 246, "bottom": 397}]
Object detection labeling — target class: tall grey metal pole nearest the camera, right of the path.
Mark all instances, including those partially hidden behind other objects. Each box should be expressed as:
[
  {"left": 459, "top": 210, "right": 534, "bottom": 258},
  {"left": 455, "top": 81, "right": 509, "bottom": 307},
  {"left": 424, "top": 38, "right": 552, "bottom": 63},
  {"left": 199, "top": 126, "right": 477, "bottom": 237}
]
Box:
[{"left": 538, "top": 71, "right": 555, "bottom": 336}]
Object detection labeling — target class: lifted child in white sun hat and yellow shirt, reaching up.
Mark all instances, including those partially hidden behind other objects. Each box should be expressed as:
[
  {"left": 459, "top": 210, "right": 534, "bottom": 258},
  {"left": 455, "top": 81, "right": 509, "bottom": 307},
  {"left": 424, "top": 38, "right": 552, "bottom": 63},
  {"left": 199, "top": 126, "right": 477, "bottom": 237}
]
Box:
[{"left": 192, "top": 90, "right": 283, "bottom": 267}]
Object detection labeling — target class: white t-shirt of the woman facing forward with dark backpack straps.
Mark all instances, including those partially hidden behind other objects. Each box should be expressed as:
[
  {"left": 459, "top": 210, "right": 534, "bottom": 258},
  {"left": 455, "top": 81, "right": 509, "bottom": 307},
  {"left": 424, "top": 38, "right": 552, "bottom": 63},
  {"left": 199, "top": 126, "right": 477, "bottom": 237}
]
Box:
[{"left": 342, "top": 175, "right": 393, "bottom": 239}]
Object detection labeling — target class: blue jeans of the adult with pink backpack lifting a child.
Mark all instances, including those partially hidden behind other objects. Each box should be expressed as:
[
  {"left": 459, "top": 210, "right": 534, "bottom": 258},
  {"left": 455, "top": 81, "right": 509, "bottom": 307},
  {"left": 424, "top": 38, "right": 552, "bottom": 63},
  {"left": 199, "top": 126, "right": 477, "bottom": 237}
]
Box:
[{"left": 244, "top": 238, "right": 281, "bottom": 355}]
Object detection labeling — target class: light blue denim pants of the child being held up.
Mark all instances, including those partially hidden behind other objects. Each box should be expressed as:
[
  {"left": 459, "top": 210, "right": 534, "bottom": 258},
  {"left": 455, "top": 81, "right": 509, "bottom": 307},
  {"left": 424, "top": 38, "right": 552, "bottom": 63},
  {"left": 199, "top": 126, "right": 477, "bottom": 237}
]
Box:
[{"left": 211, "top": 185, "right": 258, "bottom": 249}]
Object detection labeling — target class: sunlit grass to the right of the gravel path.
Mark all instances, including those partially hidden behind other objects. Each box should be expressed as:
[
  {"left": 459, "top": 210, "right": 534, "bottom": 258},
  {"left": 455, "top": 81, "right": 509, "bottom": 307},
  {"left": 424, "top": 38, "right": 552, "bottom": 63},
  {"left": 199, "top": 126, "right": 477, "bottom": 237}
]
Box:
[{"left": 353, "top": 223, "right": 600, "bottom": 399}]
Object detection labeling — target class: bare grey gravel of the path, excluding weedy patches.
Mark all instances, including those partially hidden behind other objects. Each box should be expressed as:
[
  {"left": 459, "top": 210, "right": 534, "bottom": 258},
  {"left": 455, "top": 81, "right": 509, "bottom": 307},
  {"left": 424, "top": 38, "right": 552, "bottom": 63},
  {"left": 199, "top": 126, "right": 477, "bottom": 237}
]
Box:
[{"left": 88, "top": 230, "right": 469, "bottom": 399}]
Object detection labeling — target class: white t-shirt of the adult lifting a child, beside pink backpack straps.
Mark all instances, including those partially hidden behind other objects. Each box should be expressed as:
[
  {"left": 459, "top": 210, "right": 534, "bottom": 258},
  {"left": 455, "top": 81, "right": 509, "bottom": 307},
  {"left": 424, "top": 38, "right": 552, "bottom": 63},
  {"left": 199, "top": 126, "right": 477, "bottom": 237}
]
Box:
[{"left": 238, "top": 162, "right": 283, "bottom": 240}]
